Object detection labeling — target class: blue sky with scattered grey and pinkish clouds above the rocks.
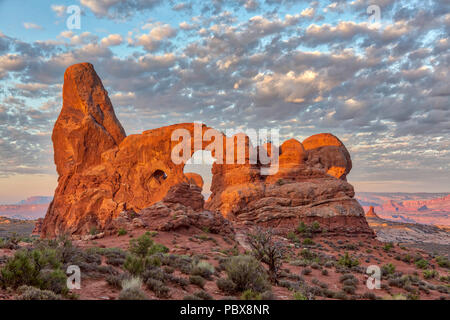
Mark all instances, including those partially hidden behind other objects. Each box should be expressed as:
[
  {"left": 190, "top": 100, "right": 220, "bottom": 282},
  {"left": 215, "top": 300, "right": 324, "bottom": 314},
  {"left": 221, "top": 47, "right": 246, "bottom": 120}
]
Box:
[{"left": 0, "top": 0, "right": 450, "bottom": 203}]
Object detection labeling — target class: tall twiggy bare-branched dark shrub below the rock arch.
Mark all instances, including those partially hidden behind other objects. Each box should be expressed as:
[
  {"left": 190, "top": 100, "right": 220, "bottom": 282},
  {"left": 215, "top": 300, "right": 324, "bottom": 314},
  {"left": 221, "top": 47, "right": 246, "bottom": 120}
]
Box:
[{"left": 247, "top": 227, "right": 286, "bottom": 283}]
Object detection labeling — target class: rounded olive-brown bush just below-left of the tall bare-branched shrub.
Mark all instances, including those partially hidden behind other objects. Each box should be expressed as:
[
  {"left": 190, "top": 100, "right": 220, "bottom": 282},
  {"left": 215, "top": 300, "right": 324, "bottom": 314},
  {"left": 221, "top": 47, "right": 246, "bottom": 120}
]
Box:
[{"left": 225, "top": 256, "right": 269, "bottom": 292}]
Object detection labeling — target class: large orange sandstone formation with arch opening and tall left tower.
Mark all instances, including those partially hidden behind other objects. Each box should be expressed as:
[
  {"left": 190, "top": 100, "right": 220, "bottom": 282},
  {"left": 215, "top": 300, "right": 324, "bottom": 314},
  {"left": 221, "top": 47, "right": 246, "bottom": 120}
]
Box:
[{"left": 41, "top": 63, "right": 371, "bottom": 237}]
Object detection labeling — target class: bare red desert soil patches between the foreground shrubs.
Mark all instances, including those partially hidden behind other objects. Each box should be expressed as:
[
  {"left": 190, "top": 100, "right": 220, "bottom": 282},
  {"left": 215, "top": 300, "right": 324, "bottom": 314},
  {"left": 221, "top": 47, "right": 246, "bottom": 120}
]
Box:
[{"left": 58, "top": 228, "right": 448, "bottom": 300}]
